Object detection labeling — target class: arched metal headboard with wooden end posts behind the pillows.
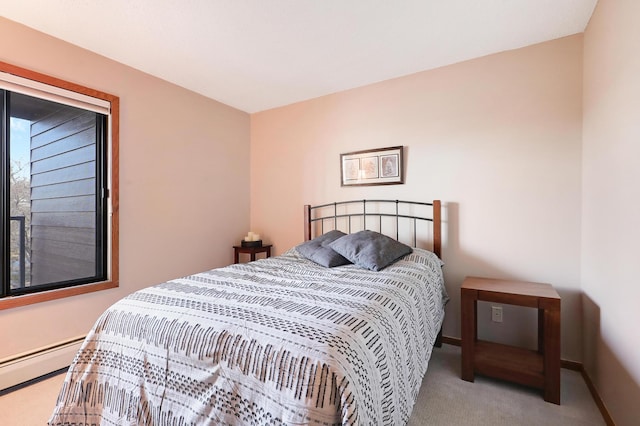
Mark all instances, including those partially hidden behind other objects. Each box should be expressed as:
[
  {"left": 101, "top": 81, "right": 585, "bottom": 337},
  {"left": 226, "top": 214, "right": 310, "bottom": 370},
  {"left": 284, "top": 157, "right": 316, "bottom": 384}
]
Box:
[{"left": 304, "top": 200, "right": 442, "bottom": 257}]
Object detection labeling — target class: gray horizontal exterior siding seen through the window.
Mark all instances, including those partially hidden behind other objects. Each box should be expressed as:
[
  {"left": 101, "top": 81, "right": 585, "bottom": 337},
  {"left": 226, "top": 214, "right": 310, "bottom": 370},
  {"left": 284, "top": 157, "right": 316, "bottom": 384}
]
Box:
[{"left": 31, "top": 100, "right": 103, "bottom": 286}]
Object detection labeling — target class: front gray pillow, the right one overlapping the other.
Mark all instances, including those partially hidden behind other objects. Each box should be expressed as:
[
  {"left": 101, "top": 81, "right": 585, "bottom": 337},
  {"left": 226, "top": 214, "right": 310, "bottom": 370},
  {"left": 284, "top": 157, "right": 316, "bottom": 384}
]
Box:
[{"left": 329, "top": 230, "right": 413, "bottom": 271}]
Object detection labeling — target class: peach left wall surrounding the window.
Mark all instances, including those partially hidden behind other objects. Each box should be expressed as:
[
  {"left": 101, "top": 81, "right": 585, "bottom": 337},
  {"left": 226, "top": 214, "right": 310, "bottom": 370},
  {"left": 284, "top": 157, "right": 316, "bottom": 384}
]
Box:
[{"left": 0, "top": 18, "right": 249, "bottom": 358}]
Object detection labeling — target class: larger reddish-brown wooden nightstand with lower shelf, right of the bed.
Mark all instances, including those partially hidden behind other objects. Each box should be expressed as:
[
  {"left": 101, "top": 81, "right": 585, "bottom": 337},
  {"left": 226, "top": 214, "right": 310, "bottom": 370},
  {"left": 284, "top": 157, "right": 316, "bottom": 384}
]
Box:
[{"left": 460, "top": 277, "right": 560, "bottom": 405}]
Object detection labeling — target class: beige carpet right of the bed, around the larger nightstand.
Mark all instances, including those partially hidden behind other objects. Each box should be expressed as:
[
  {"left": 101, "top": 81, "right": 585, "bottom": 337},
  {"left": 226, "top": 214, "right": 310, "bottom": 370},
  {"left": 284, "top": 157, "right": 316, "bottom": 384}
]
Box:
[{"left": 409, "top": 345, "right": 605, "bottom": 426}]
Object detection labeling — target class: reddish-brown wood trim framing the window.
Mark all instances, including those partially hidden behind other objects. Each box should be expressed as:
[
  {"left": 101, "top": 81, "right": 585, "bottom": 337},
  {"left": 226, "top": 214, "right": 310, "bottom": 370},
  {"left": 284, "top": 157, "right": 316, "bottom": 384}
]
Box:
[{"left": 0, "top": 61, "right": 120, "bottom": 310}]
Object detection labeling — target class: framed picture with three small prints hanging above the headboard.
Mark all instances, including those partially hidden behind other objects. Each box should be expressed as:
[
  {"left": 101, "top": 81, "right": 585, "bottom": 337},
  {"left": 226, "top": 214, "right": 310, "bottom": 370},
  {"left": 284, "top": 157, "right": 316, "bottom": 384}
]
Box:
[{"left": 340, "top": 146, "right": 404, "bottom": 186}]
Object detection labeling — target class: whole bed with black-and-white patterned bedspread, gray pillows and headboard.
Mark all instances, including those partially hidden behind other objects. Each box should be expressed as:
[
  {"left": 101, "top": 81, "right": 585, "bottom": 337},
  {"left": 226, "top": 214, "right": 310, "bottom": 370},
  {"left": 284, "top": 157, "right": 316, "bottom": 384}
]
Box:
[{"left": 49, "top": 200, "right": 448, "bottom": 426}]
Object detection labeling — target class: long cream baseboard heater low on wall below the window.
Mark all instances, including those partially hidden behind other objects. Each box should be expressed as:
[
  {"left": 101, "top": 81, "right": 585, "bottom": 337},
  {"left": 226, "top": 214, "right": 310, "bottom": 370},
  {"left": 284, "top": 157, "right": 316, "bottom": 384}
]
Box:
[{"left": 0, "top": 336, "right": 85, "bottom": 391}]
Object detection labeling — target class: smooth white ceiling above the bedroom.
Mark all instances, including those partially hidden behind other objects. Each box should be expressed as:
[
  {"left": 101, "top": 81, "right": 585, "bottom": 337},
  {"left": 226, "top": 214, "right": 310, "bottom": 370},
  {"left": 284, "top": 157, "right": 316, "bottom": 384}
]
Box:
[{"left": 0, "top": 0, "right": 597, "bottom": 113}]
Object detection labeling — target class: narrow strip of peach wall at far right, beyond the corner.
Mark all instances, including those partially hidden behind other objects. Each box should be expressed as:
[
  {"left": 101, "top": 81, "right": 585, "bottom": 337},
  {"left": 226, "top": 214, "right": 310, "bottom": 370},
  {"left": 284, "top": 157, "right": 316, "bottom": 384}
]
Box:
[{"left": 582, "top": 0, "right": 640, "bottom": 425}]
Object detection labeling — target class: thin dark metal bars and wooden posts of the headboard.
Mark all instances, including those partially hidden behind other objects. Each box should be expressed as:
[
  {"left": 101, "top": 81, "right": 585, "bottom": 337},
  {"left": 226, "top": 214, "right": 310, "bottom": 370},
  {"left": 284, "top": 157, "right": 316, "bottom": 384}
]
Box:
[{"left": 304, "top": 200, "right": 442, "bottom": 257}]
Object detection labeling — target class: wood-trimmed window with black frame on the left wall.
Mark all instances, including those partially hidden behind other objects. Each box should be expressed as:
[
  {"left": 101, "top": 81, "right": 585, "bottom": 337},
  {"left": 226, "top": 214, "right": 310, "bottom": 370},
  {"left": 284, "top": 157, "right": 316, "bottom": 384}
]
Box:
[{"left": 0, "top": 63, "right": 118, "bottom": 309}]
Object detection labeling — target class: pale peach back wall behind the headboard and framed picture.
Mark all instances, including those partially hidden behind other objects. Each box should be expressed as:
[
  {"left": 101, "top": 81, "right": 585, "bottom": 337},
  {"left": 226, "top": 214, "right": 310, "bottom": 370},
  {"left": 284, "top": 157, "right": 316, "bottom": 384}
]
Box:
[{"left": 251, "top": 35, "right": 582, "bottom": 361}]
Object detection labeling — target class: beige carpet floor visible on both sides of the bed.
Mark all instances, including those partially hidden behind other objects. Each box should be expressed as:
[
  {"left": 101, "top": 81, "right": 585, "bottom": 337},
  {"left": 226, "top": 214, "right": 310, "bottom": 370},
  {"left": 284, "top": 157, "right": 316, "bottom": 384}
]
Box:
[{"left": 0, "top": 345, "right": 605, "bottom": 426}]
